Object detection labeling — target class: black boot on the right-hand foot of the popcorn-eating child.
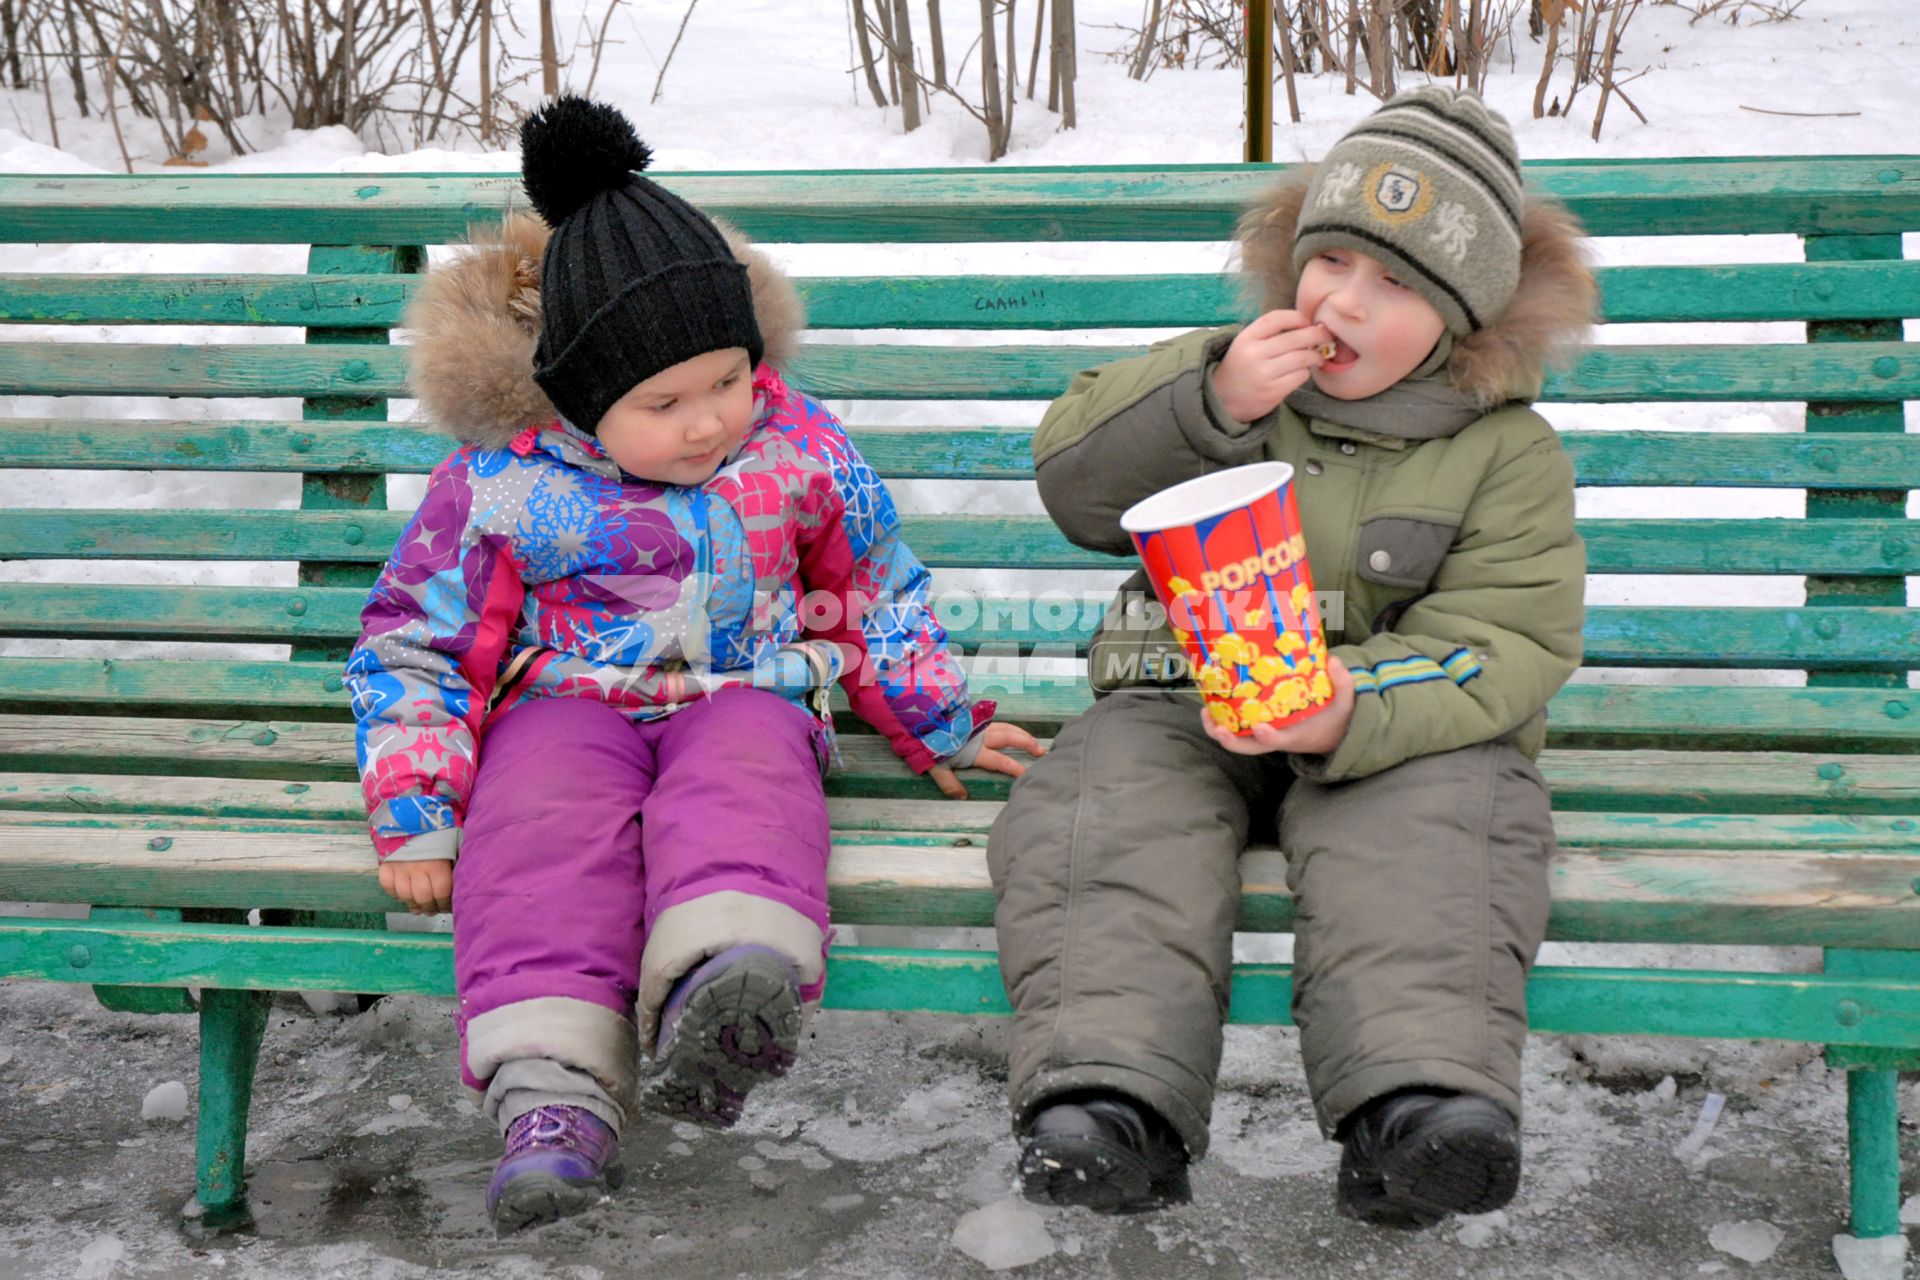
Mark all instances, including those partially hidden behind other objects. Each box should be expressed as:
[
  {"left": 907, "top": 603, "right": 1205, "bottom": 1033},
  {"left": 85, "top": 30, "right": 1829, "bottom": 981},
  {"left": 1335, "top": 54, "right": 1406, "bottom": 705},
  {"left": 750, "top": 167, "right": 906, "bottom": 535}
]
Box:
[{"left": 1338, "top": 1090, "right": 1521, "bottom": 1230}]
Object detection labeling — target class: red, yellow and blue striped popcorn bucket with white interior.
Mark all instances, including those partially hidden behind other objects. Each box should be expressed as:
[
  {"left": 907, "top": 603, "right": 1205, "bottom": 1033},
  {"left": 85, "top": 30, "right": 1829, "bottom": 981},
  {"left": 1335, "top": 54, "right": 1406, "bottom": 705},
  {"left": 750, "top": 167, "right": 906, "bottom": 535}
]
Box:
[{"left": 1119, "top": 462, "right": 1332, "bottom": 735}]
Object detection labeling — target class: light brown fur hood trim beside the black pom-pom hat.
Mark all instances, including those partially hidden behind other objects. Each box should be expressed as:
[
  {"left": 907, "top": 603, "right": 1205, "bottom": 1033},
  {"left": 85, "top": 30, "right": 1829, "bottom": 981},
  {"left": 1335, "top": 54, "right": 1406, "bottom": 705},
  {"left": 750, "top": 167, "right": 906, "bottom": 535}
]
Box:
[{"left": 405, "top": 213, "right": 806, "bottom": 449}]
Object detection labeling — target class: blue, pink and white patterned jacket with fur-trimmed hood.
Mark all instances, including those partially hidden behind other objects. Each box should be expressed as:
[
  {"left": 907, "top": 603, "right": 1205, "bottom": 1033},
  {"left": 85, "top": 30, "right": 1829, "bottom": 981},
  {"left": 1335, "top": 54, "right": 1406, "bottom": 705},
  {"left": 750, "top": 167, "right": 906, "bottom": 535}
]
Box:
[{"left": 348, "top": 225, "right": 993, "bottom": 860}]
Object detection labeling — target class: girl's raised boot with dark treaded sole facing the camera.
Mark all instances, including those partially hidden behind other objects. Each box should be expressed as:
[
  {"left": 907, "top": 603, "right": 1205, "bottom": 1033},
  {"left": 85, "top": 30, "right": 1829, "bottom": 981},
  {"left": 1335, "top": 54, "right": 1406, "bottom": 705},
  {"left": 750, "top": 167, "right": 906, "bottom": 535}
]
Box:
[{"left": 641, "top": 944, "right": 801, "bottom": 1128}]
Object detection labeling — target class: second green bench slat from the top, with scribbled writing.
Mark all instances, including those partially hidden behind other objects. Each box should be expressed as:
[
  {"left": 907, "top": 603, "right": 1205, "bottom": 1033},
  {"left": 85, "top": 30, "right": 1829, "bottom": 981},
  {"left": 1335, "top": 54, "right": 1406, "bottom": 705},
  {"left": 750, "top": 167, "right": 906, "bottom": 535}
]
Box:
[{"left": 0, "top": 261, "right": 1920, "bottom": 330}]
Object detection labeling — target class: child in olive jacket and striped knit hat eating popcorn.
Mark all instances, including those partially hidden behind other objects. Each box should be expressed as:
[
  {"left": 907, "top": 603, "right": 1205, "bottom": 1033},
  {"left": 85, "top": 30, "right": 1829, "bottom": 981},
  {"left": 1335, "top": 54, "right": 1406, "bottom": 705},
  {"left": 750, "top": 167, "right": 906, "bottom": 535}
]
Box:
[{"left": 989, "top": 86, "right": 1596, "bottom": 1228}]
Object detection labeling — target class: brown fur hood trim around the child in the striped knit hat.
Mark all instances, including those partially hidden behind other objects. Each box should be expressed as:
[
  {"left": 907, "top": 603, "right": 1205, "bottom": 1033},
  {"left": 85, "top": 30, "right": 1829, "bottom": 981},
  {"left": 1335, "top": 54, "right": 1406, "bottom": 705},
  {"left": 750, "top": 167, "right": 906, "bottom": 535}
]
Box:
[{"left": 1236, "top": 169, "right": 1599, "bottom": 409}]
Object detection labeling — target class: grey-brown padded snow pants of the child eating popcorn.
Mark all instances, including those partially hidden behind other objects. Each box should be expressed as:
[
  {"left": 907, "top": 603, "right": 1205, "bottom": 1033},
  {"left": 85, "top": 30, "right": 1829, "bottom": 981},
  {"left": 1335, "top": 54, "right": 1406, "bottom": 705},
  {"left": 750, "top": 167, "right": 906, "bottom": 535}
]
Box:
[{"left": 987, "top": 689, "right": 1553, "bottom": 1157}]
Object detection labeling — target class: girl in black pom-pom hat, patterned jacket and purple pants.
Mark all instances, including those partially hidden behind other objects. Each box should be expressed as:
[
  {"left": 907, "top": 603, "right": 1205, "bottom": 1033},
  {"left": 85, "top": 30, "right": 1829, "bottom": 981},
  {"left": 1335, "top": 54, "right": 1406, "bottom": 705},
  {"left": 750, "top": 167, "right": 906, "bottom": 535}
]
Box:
[{"left": 348, "top": 98, "right": 1037, "bottom": 1230}]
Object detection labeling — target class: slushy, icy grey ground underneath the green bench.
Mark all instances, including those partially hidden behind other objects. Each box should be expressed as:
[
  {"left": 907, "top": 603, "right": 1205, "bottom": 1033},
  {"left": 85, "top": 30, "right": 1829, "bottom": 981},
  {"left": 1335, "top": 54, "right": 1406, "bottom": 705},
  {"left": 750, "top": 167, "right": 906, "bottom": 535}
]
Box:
[{"left": 0, "top": 984, "right": 1920, "bottom": 1280}]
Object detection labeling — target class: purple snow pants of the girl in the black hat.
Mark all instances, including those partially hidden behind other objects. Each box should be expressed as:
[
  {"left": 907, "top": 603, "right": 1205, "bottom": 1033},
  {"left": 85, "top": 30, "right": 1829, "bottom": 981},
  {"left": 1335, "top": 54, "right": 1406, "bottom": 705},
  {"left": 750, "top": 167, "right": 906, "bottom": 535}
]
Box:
[{"left": 453, "top": 689, "right": 829, "bottom": 1088}]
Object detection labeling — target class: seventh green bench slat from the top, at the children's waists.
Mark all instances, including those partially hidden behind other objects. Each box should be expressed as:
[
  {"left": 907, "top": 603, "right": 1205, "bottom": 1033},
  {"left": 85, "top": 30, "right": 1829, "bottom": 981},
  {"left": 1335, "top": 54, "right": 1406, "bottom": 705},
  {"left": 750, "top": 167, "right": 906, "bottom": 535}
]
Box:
[{"left": 0, "top": 658, "right": 1920, "bottom": 752}]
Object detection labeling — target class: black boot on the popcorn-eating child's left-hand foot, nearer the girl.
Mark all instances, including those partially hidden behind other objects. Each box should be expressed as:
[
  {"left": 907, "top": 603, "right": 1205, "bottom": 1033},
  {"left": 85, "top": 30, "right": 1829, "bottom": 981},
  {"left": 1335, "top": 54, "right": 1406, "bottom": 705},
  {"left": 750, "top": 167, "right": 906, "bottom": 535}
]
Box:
[{"left": 1020, "top": 1094, "right": 1192, "bottom": 1213}]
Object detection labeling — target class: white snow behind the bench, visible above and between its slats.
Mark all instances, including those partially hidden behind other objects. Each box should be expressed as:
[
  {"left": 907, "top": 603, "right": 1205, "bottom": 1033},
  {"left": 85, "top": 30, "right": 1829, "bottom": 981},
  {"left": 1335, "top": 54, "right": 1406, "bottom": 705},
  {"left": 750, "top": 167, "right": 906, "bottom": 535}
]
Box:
[{"left": 0, "top": 0, "right": 1920, "bottom": 660}]
